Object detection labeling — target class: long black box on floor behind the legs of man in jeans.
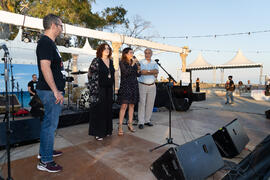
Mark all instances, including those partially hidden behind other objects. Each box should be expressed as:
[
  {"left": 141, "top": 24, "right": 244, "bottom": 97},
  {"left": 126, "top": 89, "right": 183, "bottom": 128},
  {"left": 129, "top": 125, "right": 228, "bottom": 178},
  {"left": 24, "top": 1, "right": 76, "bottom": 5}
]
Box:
[{"left": 0, "top": 119, "right": 40, "bottom": 149}]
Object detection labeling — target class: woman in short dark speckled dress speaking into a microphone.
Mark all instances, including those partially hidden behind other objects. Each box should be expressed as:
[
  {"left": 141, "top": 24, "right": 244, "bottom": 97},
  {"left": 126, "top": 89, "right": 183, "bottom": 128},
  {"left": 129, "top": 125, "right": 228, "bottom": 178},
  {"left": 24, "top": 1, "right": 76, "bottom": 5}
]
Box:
[{"left": 118, "top": 48, "right": 140, "bottom": 136}]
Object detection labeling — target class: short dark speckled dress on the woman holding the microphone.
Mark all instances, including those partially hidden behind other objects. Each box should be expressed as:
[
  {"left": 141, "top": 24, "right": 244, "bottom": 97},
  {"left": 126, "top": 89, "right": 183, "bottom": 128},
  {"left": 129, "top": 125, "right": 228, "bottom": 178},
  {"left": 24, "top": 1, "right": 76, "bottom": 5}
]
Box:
[{"left": 118, "top": 61, "right": 140, "bottom": 104}]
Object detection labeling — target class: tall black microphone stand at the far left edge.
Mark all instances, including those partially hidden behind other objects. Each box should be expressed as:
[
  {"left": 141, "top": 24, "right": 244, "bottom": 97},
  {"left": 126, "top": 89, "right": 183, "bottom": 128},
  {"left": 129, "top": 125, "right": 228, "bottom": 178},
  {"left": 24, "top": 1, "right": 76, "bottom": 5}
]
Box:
[{"left": 1, "top": 44, "right": 12, "bottom": 180}]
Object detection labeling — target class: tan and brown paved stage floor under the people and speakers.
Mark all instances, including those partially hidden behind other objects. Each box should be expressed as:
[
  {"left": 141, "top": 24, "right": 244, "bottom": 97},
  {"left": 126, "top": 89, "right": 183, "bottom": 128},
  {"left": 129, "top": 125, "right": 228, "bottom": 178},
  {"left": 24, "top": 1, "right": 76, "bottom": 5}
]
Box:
[{"left": 0, "top": 95, "right": 270, "bottom": 180}]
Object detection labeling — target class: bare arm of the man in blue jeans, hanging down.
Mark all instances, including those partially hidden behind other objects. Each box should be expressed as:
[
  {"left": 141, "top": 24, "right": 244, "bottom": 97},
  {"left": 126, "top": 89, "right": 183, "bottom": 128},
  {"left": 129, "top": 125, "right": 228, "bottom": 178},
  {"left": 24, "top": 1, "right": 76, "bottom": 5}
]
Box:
[{"left": 40, "top": 59, "right": 64, "bottom": 104}]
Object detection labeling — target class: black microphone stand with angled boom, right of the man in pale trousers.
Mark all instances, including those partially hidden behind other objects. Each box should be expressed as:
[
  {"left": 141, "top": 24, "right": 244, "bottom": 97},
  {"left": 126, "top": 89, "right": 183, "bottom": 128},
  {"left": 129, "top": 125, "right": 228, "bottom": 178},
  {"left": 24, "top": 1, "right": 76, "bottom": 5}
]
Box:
[{"left": 150, "top": 59, "right": 179, "bottom": 152}]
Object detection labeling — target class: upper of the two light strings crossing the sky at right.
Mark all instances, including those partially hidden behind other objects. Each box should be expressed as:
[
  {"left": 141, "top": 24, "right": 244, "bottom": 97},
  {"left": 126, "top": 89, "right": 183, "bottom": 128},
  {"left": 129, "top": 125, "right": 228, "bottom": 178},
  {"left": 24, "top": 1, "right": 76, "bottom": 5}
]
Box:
[{"left": 144, "top": 30, "right": 270, "bottom": 39}]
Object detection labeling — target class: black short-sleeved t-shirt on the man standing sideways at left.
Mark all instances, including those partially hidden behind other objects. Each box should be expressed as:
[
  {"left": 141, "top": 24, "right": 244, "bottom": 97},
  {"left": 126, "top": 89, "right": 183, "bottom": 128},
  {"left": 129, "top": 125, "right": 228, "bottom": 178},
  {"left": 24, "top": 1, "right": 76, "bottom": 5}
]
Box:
[{"left": 36, "top": 35, "right": 65, "bottom": 91}]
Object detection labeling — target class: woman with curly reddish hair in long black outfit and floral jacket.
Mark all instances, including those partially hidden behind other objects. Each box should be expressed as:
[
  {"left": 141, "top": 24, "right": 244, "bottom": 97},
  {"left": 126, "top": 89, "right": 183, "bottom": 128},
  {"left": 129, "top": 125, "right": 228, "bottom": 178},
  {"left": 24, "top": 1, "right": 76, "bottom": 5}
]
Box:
[{"left": 88, "top": 43, "right": 114, "bottom": 140}]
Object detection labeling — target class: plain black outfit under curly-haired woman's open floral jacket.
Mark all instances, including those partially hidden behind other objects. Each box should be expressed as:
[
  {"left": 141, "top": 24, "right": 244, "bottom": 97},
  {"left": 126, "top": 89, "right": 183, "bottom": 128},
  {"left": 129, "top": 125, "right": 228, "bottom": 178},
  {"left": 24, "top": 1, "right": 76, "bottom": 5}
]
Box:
[{"left": 89, "top": 59, "right": 114, "bottom": 137}]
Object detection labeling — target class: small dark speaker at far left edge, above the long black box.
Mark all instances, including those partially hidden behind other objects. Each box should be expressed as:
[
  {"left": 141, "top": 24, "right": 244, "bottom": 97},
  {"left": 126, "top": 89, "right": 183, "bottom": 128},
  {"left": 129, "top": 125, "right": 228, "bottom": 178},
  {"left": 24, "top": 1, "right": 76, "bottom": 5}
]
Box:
[{"left": 0, "top": 94, "right": 21, "bottom": 114}]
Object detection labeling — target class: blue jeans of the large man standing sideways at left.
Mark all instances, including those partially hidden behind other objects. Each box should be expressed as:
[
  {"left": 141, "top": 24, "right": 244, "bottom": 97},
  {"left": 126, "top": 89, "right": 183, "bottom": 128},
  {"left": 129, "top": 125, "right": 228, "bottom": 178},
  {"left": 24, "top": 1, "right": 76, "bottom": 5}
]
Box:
[{"left": 37, "top": 90, "right": 61, "bottom": 163}]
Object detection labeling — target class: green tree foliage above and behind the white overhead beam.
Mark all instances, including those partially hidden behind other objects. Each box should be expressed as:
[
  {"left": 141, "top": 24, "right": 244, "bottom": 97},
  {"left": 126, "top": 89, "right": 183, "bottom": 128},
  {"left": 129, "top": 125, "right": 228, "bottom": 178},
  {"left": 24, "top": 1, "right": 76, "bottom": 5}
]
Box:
[{"left": 0, "top": 0, "right": 127, "bottom": 50}]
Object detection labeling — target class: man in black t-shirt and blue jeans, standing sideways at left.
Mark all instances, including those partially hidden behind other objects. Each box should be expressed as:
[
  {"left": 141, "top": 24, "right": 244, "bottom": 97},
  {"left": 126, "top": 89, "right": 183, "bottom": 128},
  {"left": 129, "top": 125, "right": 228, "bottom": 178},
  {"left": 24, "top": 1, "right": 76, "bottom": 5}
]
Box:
[{"left": 36, "top": 14, "right": 65, "bottom": 172}]
